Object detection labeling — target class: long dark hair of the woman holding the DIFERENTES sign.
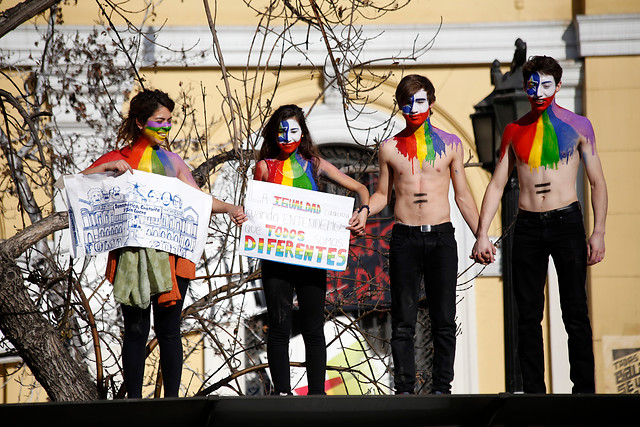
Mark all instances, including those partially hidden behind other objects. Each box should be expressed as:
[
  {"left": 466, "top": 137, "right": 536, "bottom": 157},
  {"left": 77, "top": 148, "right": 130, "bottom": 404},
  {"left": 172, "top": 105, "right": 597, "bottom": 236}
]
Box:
[{"left": 258, "top": 104, "right": 320, "bottom": 165}]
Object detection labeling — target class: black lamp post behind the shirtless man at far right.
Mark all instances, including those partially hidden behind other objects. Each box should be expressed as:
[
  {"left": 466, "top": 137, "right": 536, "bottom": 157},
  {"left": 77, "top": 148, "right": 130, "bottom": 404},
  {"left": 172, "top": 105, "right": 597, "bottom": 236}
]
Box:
[{"left": 471, "top": 39, "right": 530, "bottom": 393}]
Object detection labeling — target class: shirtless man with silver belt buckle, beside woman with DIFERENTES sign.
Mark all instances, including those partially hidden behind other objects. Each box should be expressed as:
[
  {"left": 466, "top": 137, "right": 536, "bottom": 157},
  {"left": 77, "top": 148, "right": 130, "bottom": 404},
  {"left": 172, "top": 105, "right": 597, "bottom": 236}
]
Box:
[{"left": 370, "top": 74, "right": 478, "bottom": 394}]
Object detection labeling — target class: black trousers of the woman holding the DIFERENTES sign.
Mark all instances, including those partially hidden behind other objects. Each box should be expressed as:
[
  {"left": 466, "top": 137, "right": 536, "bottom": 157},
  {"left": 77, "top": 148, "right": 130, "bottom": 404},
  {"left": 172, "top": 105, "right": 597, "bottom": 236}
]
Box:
[{"left": 262, "top": 260, "right": 327, "bottom": 394}]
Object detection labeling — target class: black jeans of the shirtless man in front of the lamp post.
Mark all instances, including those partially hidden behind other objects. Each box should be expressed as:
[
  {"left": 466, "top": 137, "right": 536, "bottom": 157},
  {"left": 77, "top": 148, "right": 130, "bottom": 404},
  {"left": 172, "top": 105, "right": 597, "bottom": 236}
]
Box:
[{"left": 512, "top": 202, "right": 595, "bottom": 393}]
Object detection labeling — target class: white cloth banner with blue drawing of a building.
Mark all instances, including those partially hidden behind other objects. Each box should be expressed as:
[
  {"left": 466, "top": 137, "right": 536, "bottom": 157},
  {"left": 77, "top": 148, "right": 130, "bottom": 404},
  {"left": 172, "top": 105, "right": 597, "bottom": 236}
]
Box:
[{"left": 64, "top": 170, "right": 212, "bottom": 262}]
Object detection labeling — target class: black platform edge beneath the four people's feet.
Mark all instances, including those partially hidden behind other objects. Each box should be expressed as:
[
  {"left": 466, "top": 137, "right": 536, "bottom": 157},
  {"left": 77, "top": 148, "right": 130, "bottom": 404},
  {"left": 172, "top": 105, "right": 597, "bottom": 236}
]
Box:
[{"left": 0, "top": 393, "right": 640, "bottom": 427}]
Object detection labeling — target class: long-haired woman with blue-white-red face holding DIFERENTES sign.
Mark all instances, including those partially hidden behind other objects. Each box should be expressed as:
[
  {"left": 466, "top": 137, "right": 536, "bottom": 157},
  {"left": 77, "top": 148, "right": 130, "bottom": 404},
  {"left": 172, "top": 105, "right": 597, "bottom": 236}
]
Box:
[{"left": 254, "top": 105, "right": 369, "bottom": 395}]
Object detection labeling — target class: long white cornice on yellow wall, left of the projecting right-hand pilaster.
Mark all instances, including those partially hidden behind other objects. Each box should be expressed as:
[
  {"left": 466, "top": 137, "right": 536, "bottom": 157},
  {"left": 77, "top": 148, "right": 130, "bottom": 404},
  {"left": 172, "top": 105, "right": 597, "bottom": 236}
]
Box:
[{"left": 0, "top": 21, "right": 578, "bottom": 68}]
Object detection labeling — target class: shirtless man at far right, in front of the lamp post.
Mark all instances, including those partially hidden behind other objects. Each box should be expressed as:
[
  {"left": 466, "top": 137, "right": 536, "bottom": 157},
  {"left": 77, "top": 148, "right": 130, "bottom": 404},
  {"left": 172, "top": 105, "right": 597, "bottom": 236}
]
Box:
[{"left": 471, "top": 56, "right": 607, "bottom": 393}]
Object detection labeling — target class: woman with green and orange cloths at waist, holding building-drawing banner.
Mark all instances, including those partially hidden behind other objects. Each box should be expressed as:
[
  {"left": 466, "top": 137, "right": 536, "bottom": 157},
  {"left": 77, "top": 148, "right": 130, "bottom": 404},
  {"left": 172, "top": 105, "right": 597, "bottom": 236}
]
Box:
[{"left": 82, "top": 90, "right": 246, "bottom": 398}]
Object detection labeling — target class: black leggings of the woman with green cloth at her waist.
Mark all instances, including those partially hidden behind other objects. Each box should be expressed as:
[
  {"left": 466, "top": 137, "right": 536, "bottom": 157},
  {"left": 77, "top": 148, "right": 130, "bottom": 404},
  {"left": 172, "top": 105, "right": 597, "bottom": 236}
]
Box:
[{"left": 120, "top": 277, "right": 189, "bottom": 398}]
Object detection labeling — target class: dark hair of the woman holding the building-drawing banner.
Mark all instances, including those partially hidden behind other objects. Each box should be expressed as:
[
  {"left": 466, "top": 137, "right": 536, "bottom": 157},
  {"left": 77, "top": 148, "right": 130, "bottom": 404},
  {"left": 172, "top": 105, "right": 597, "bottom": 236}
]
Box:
[{"left": 117, "top": 89, "right": 175, "bottom": 143}]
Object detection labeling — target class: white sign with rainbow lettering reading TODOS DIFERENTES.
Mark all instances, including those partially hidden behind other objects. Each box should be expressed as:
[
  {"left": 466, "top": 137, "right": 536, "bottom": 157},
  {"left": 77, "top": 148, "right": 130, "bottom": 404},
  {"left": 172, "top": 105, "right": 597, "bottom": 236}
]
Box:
[{"left": 240, "top": 181, "right": 354, "bottom": 271}]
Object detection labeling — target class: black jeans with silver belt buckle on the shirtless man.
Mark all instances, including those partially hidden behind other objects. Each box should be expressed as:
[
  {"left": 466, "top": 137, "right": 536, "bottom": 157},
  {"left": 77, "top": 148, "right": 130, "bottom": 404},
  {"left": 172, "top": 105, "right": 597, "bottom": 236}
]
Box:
[{"left": 389, "top": 222, "right": 458, "bottom": 393}]
